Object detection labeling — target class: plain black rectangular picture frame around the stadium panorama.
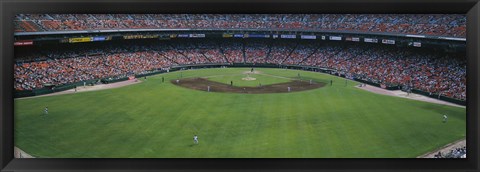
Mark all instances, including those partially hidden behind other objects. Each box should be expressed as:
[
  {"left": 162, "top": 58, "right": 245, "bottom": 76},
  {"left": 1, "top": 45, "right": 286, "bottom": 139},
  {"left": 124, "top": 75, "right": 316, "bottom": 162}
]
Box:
[{"left": 0, "top": 0, "right": 480, "bottom": 171}]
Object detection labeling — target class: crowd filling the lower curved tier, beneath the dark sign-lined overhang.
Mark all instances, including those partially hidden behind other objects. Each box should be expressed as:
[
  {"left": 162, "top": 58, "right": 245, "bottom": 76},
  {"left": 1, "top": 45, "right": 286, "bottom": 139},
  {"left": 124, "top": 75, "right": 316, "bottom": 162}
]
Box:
[{"left": 15, "top": 39, "right": 466, "bottom": 100}]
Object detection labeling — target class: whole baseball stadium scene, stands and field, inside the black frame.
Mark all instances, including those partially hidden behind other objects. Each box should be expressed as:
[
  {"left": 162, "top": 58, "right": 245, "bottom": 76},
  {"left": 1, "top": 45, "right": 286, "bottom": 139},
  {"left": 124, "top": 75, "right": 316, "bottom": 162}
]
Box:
[{"left": 13, "top": 14, "right": 467, "bottom": 158}]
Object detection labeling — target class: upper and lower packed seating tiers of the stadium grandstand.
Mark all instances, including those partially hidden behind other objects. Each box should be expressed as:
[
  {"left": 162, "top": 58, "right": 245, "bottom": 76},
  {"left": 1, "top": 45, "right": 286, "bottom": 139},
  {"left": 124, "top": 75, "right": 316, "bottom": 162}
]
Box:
[{"left": 15, "top": 14, "right": 466, "bottom": 100}]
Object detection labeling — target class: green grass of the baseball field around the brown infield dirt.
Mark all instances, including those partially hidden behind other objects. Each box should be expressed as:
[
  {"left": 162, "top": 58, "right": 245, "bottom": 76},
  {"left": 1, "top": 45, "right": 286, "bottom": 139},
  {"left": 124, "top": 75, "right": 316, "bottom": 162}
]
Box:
[{"left": 14, "top": 68, "right": 466, "bottom": 158}]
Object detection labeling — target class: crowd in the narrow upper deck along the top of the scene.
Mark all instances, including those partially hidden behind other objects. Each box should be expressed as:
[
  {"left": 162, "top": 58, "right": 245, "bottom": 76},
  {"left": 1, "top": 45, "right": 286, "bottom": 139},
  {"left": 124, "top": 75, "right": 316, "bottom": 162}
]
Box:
[{"left": 15, "top": 14, "right": 466, "bottom": 37}]
